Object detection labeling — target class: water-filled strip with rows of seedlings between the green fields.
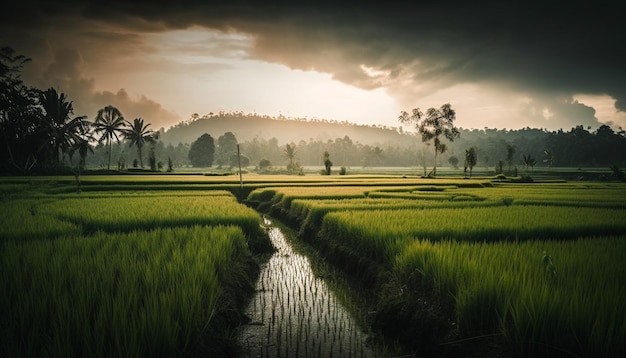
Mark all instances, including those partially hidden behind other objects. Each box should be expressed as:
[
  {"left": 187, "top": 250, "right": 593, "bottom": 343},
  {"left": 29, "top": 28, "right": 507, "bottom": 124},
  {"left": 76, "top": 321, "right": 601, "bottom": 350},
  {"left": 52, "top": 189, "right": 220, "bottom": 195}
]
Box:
[{"left": 238, "top": 218, "right": 380, "bottom": 357}]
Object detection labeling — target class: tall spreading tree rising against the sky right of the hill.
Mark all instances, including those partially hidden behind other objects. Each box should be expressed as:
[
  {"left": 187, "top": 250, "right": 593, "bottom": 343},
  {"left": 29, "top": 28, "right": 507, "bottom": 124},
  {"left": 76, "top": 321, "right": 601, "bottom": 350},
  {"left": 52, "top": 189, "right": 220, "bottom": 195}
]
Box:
[{"left": 398, "top": 103, "right": 460, "bottom": 176}]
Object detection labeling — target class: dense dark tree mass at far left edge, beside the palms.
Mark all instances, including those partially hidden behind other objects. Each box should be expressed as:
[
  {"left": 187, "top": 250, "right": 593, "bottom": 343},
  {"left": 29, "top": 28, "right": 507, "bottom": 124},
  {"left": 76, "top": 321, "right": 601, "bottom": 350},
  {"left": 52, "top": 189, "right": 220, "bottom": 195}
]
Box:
[{"left": 0, "top": 47, "right": 96, "bottom": 174}]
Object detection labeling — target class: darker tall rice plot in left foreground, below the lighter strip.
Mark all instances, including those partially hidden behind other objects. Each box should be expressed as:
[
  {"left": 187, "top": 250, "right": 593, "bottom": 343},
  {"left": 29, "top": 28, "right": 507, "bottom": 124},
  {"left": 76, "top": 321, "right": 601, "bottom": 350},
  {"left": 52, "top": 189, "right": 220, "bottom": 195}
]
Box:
[{"left": 0, "top": 226, "right": 252, "bottom": 357}]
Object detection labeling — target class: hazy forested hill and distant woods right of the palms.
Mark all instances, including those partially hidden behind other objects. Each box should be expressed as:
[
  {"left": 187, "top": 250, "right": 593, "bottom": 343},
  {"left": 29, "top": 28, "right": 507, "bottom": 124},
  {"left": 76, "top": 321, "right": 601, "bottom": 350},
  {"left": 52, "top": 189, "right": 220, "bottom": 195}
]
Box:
[{"left": 88, "top": 112, "right": 626, "bottom": 172}]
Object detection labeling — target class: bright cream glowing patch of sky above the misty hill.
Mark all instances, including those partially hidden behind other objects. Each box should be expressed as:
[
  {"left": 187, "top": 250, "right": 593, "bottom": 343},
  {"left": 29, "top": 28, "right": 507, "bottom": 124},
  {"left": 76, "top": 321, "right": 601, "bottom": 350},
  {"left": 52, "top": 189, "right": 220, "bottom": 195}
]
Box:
[{"left": 140, "top": 27, "right": 398, "bottom": 124}]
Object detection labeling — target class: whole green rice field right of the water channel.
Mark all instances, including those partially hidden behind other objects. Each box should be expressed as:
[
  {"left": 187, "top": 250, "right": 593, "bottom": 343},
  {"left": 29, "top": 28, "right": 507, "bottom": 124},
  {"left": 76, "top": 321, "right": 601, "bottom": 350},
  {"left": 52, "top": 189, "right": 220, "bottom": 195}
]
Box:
[{"left": 252, "top": 183, "right": 626, "bottom": 357}]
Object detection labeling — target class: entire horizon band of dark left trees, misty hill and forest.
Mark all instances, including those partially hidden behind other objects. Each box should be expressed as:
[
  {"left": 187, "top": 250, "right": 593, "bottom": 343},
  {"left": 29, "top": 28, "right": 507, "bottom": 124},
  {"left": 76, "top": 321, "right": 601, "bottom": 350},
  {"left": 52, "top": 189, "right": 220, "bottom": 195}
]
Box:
[{"left": 0, "top": 47, "right": 626, "bottom": 175}]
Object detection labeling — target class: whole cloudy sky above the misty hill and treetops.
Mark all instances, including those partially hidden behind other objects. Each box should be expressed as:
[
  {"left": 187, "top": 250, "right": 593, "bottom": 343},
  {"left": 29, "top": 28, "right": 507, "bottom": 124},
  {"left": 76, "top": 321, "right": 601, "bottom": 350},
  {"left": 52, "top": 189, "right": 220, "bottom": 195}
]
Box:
[{"left": 0, "top": 0, "right": 626, "bottom": 131}]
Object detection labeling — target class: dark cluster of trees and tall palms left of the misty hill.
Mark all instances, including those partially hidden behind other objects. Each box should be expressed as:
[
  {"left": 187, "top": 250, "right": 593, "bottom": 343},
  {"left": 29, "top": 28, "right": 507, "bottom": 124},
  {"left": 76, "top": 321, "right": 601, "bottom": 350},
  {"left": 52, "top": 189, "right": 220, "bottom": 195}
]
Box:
[{"left": 0, "top": 47, "right": 158, "bottom": 174}]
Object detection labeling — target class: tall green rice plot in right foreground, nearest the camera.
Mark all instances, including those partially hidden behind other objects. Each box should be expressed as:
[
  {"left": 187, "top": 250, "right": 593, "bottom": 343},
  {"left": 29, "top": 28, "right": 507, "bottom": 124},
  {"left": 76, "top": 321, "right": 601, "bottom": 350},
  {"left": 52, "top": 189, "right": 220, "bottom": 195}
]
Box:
[{"left": 395, "top": 235, "right": 626, "bottom": 357}]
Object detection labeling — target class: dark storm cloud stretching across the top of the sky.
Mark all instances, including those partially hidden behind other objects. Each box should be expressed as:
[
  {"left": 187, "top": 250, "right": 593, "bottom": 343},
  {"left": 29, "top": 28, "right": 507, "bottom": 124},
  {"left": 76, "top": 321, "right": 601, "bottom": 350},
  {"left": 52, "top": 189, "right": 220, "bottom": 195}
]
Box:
[{"left": 0, "top": 0, "right": 626, "bottom": 129}]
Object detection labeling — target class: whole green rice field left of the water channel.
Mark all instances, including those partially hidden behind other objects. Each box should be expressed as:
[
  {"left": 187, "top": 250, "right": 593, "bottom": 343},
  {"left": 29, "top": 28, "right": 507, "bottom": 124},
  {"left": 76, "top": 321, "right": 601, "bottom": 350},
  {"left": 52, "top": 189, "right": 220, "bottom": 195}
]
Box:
[{"left": 0, "top": 188, "right": 271, "bottom": 357}]
